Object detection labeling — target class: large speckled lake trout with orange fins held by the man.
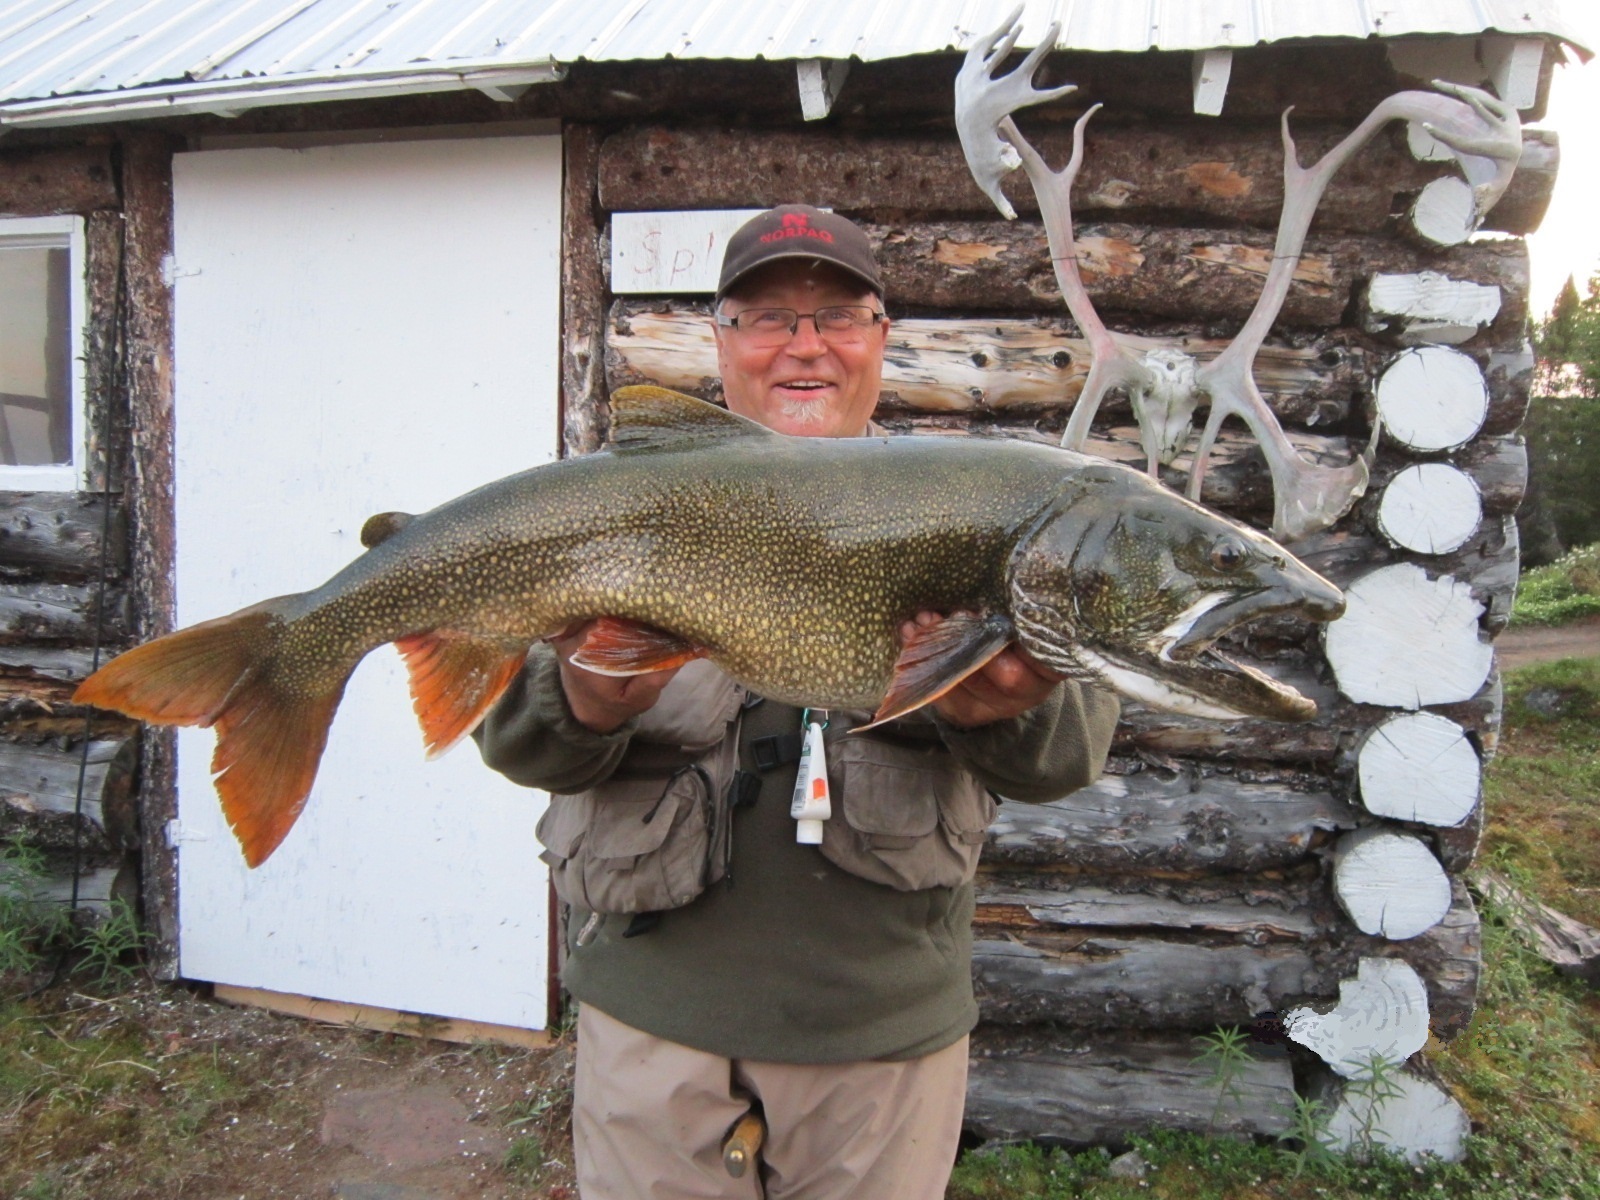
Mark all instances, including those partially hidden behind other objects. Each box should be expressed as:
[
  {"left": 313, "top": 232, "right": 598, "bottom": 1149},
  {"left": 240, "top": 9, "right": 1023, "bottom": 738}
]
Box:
[{"left": 75, "top": 387, "right": 1344, "bottom": 866}]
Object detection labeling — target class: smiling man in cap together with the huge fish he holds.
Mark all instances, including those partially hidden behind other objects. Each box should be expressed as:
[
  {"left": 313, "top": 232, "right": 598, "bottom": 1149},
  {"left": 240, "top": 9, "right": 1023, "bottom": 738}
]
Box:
[{"left": 74, "top": 206, "right": 1344, "bottom": 1200}]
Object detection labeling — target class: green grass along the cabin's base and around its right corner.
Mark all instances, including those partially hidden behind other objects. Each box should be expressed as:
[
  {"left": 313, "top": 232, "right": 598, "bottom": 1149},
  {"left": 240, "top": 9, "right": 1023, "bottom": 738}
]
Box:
[{"left": 949, "top": 659, "right": 1600, "bottom": 1200}]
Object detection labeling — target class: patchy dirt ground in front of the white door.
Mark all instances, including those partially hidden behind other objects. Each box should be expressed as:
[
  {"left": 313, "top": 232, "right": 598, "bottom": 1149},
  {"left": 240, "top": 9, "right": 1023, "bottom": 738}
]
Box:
[{"left": 0, "top": 981, "right": 578, "bottom": 1200}]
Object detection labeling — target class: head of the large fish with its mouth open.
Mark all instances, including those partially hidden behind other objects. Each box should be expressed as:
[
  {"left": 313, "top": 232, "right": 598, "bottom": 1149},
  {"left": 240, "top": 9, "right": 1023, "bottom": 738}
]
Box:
[{"left": 1008, "top": 462, "right": 1344, "bottom": 722}]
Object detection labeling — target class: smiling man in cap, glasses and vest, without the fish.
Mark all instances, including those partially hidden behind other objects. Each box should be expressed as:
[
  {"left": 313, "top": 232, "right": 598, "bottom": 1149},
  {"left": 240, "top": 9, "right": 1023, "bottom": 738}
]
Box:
[{"left": 478, "top": 205, "right": 1117, "bottom": 1200}]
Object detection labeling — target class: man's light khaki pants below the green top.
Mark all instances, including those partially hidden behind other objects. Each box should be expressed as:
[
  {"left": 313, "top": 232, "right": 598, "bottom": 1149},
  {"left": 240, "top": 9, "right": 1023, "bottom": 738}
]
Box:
[{"left": 573, "top": 1005, "right": 966, "bottom": 1200}]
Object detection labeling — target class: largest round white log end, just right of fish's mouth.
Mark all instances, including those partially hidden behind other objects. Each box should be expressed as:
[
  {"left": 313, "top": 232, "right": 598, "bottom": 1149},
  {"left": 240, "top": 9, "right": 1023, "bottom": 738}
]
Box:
[{"left": 1323, "top": 563, "right": 1494, "bottom": 709}]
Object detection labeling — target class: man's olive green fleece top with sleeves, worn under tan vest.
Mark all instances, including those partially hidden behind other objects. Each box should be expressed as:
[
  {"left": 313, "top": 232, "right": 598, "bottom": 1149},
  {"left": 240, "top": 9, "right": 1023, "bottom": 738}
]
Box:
[{"left": 475, "top": 646, "right": 1118, "bottom": 1062}]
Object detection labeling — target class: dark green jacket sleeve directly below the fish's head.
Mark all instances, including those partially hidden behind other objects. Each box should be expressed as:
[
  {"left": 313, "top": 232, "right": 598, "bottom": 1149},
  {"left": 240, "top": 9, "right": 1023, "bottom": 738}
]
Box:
[{"left": 934, "top": 680, "right": 1122, "bottom": 803}]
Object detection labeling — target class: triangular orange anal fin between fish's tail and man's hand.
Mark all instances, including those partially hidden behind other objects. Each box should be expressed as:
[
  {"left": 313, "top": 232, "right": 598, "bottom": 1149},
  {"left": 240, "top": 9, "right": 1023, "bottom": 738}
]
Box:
[{"left": 395, "top": 629, "right": 528, "bottom": 758}]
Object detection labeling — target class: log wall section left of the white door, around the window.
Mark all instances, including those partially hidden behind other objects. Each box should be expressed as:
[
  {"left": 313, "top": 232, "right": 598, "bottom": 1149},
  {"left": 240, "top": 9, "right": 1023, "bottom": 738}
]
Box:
[{"left": 0, "top": 139, "right": 139, "bottom": 910}]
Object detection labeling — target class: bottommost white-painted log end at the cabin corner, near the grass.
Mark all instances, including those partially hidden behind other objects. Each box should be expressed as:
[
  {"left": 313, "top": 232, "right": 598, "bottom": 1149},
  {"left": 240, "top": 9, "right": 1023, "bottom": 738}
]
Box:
[{"left": 1318, "top": 1070, "right": 1472, "bottom": 1166}]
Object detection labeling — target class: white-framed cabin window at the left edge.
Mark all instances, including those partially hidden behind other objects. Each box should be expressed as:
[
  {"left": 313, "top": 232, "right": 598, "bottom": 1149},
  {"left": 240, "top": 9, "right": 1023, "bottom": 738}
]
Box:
[{"left": 0, "top": 216, "right": 85, "bottom": 491}]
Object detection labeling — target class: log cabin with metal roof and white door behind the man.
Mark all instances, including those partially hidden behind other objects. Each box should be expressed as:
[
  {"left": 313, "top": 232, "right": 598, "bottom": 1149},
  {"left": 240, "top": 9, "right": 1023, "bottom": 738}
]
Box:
[{"left": 0, "top": 0, "right": 1587, "bottom": 1157}]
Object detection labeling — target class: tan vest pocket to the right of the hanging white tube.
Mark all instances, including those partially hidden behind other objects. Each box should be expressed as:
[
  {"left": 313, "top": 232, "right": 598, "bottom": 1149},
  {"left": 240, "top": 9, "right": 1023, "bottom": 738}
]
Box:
[{"left": 821, "top": 738, "right": 995, "bottom": 891}]
